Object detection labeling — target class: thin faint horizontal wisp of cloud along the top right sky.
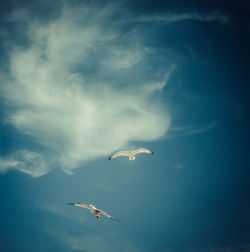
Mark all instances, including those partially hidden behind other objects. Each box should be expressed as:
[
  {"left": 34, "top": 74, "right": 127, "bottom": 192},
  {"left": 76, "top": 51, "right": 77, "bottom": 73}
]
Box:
[{"left": 128, "top": 11, "right": 228, "bottom": 24}]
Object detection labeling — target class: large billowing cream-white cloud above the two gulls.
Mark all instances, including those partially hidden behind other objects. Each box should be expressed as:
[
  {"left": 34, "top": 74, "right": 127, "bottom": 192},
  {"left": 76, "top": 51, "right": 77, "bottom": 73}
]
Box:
[{"left": 1, "top": 4, "right": 173, "bottom": 176}]
